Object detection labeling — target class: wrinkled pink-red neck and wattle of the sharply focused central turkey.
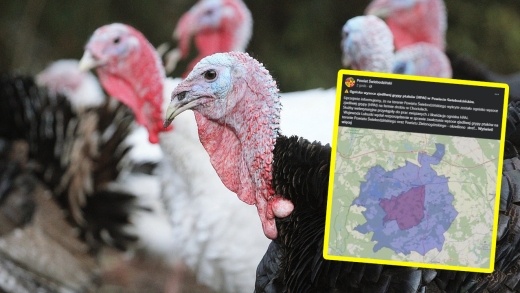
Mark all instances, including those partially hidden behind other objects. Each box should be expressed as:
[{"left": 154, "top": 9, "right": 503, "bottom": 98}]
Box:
[{"left": 195, "top": 62, "right": 281, "bottom": 239}]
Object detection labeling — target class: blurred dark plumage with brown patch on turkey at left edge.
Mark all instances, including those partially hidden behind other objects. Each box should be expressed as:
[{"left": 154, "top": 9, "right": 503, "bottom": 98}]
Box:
[{"left": 0, "top": 74, "right": 139, "bottom": 249}]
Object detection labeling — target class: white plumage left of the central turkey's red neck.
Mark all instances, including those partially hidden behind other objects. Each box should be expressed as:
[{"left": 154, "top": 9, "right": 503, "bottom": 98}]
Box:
[{"left": 120, "top": 79, "right": 270, "bottom": 293}]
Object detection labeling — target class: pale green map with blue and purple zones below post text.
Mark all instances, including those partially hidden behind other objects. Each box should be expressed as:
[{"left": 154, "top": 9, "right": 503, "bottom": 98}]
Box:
[{"left": 328, "top": 127, "right": 500, "bottom": 268}]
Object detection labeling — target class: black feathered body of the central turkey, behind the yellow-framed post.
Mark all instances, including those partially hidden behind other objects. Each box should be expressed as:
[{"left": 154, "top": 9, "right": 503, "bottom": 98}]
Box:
[{"left": 255, "top": 132, "right": 520, "bottom": 293}]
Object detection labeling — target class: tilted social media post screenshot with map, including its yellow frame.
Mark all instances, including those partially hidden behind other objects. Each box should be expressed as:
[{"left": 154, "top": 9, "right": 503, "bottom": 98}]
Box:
[{"left": 323, "top": 70, "right": 508, "bottom": 272}]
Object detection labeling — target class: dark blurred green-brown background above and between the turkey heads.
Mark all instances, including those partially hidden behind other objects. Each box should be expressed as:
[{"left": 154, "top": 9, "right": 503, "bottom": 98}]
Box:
[{"left": 0, "top": 0, "right": 520, "bottom": 92}]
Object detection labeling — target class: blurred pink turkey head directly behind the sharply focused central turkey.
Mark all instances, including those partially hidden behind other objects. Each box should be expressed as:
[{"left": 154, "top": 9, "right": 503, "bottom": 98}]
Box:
[{"left": 173, "top": 0, "right": 253, "bottom": 77}]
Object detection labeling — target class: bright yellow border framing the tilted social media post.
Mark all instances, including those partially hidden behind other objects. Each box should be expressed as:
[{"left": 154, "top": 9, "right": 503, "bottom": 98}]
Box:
[{"left": 323, "top": 69, "right": 509, "bottom": 273}]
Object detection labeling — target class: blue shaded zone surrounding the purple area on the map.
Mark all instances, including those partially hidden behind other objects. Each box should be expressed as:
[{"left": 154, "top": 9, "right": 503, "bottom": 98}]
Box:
[{"left": 352, "top": 143, "right": 458, "bottom": 255}]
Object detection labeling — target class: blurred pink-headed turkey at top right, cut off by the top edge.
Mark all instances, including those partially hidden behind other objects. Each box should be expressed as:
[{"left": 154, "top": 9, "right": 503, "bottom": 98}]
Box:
[{"left": 365, "top": 0, "right": 520, "bottom": 100}]
